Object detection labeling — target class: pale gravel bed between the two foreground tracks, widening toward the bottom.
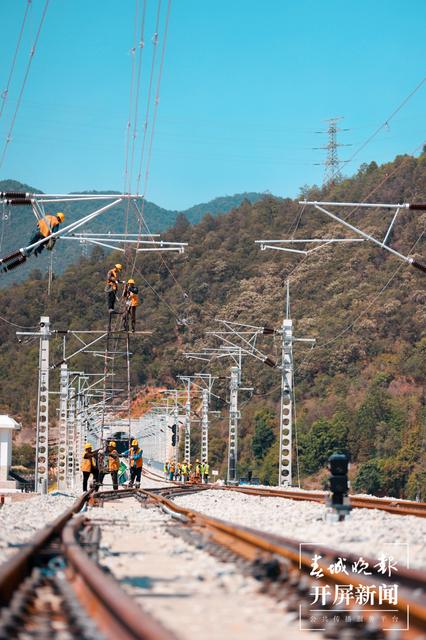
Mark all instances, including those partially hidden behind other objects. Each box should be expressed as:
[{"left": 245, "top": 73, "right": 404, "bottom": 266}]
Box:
[{"left": 86, "top": 498, "right": 314, "bottom": 640}]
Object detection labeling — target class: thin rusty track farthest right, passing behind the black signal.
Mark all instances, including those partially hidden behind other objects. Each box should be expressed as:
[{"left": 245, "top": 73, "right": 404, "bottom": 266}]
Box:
[{"left": 144, "top": 469, "right": 426, "bottom": 518}]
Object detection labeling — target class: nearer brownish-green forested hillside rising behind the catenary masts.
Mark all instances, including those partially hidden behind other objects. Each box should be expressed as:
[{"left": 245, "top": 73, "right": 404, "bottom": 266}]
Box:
[{"left": 0, "top": 153, "right": 426, "bottom": 500}]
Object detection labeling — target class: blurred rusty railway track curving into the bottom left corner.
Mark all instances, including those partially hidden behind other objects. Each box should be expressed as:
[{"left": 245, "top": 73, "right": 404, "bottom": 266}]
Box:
[{"left": 0, "top": 493, "right": 175, "bottom": 640}]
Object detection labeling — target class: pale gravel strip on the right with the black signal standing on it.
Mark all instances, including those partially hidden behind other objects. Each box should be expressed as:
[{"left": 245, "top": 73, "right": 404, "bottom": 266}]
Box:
[{"left": 175, "top": 490, "right": 426, "bottom": 569}]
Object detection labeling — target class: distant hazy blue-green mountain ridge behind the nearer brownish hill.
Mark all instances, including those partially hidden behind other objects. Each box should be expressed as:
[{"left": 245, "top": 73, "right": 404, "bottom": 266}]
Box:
[{"left": 0, "top": 180, "right": 263, "bottom": 288}]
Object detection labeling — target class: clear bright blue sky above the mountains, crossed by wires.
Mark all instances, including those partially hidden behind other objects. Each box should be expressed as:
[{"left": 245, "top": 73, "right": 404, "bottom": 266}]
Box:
[{"left": 0, "top": 0, "right": 426, "bottom": 209}]
